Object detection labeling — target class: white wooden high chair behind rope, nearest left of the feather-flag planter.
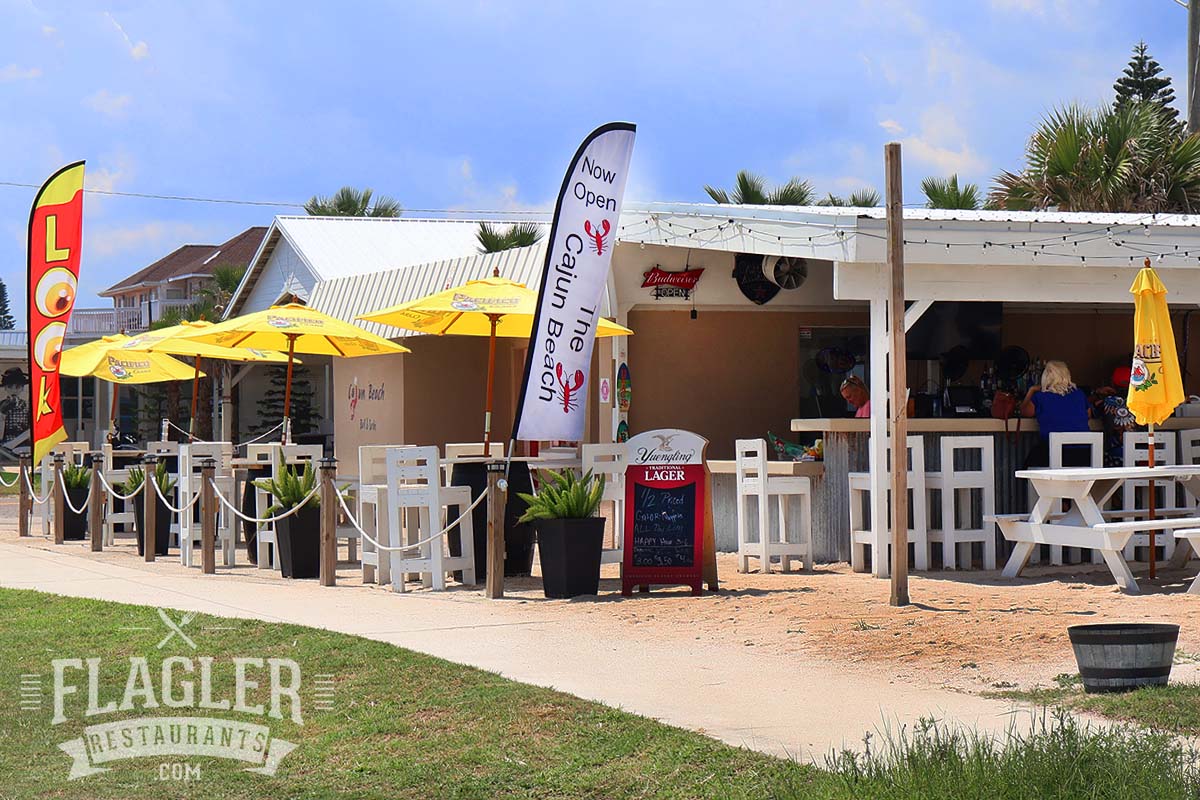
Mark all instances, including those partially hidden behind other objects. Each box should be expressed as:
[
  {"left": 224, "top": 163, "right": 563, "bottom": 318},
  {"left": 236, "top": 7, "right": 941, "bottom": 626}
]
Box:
[{"left": 385, "top": 447, "right": 475, "bottom": 591}]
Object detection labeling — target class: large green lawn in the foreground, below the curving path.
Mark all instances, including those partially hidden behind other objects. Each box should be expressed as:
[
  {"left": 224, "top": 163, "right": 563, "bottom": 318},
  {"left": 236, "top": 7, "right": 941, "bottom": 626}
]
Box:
[{"left": 0, "top": 589, "right": 1200, "bottom": 800}]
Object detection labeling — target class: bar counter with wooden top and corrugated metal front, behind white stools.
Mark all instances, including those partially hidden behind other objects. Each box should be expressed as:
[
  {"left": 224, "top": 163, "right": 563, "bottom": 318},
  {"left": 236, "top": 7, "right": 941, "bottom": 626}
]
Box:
[{"left": 787, "top": 416, "right": 1200, "bottom": 561}]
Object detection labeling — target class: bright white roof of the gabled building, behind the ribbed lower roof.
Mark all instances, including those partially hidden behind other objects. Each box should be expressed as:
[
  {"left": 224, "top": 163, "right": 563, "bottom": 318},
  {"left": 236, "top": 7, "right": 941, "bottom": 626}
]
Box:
[{"left": 228, "top": 216, "right": 545, "bottom": 315}]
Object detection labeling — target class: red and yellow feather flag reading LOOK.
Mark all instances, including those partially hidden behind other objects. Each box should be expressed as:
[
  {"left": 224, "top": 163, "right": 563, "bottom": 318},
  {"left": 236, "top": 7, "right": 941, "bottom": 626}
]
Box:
[{"left": 28, "top": 161, "right": 84, "bottom": 465}]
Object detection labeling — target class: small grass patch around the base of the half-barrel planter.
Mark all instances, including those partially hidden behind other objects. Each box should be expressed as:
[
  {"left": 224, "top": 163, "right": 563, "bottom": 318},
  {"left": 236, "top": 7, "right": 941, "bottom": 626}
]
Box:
[{"left": 994, "top": 675, "right": 1200, "bottom": 736}]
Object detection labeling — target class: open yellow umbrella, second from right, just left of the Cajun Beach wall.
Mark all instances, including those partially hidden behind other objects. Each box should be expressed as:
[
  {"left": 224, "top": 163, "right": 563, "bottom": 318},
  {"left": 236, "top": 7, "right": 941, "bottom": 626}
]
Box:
[{"left": 180, "top": 303, "right": 410, "bottom": 440}]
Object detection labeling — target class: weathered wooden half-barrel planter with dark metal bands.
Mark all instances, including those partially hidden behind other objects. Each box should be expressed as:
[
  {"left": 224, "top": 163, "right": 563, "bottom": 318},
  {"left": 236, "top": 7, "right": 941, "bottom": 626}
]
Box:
[{"left": 1067, "top": 622, "right": 1180, "bottom": 693}]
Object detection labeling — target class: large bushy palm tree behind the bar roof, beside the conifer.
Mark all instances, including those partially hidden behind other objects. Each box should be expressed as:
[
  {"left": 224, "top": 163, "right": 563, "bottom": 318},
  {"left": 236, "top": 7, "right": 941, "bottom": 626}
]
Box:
[{"left": 989, "top": 103, "right": 1200, "bottom": 213}]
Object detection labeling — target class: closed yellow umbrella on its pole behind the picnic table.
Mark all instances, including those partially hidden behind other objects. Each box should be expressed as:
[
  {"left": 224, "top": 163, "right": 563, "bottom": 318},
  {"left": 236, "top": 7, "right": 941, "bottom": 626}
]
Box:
[{"left": 1126, "top": 258, "right": 1184, "bottom": 578}]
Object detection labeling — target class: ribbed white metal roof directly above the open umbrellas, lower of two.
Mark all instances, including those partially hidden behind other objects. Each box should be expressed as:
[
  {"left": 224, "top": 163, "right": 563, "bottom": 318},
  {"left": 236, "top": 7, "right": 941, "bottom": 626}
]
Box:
[{"left": 308, "top": 241, "right": 546, "bottom": 338}]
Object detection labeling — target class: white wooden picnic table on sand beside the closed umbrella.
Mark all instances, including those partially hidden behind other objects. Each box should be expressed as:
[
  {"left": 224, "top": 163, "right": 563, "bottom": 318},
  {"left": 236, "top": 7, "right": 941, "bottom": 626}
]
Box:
[{"left": 992, "top": 464, "right": 1200, "bottom": 594}]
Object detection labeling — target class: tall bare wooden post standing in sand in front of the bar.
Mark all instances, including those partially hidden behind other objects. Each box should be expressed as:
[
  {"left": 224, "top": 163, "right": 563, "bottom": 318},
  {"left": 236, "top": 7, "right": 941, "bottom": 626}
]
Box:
[{"left": 876, "top": 142, "right": 907, "bottom": 606}]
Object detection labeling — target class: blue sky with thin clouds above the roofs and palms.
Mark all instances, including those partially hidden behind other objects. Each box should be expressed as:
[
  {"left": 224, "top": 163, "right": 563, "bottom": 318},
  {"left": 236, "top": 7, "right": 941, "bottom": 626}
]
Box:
[{"left": 0, "top": 0, "right": 1187, "bottom": 320}]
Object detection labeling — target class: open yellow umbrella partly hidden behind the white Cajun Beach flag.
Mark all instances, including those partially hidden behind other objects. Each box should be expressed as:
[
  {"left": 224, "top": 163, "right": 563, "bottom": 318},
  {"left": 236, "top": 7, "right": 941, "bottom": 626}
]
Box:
[{"left": 359, "top": 270, "right": 634, "bottom": 447}]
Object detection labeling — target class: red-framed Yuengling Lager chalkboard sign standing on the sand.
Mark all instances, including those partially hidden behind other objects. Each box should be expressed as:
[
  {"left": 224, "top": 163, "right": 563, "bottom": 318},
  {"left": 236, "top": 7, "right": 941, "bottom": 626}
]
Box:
[{"left": 622, "top": 429, "right": 708, "bottom": 595}]
